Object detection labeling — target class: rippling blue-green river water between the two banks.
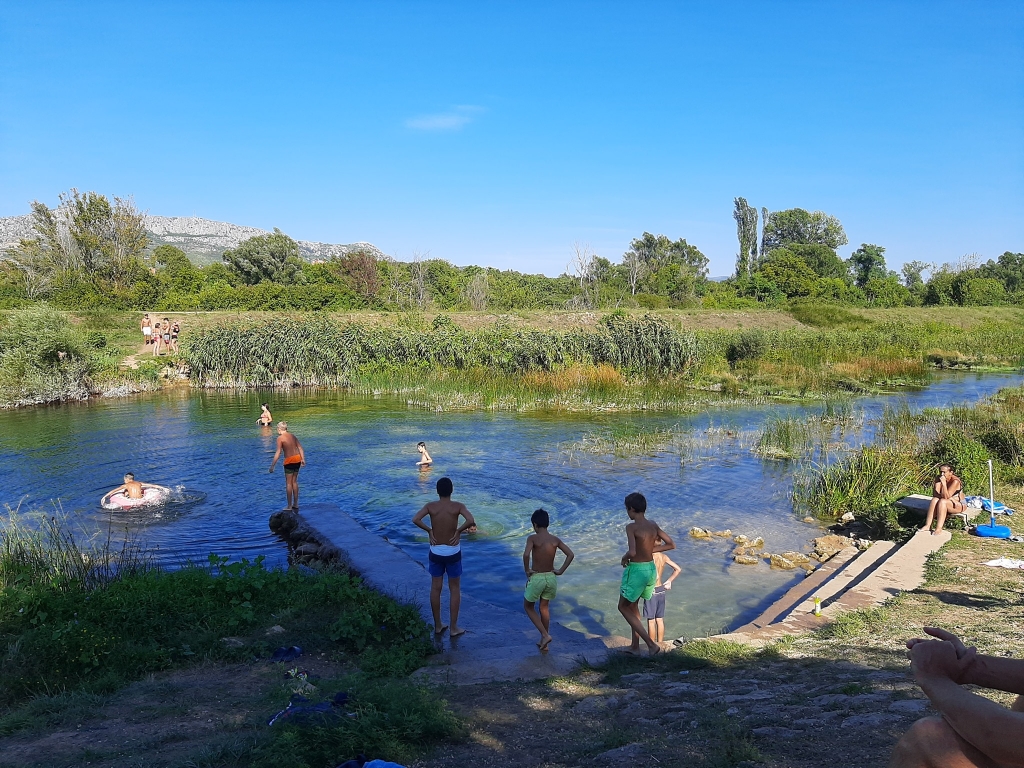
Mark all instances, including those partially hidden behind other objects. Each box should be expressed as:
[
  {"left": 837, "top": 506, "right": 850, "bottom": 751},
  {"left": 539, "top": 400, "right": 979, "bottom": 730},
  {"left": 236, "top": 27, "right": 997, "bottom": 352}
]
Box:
[{"left": 0, "top": 375, "right": 1022, "bottom": 637}]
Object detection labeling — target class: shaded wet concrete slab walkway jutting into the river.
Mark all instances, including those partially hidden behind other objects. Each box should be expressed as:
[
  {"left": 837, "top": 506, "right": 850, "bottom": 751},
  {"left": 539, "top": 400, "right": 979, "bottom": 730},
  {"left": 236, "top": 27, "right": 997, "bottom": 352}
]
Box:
[{"left": 300, "top": 504, "right": 610, "bottom": 685}]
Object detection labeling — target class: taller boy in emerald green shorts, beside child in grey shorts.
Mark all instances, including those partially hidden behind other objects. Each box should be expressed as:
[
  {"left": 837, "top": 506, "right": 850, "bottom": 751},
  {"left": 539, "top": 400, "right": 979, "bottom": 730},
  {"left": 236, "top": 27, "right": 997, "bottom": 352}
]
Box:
[{"left": 618, "top": 494, "right": 676, "bottom": 655}]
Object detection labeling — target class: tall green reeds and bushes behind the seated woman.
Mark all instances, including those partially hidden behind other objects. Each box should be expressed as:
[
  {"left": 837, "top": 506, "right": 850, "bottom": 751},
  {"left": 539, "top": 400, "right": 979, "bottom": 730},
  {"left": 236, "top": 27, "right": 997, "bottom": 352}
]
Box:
[{"left": 794, "top": 387, "right": 1024, "bottom": 539}]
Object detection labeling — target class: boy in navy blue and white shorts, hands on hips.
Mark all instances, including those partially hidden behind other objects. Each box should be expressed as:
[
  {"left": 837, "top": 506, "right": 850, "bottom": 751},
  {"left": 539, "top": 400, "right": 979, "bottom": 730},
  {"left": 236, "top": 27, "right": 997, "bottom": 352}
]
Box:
[{"left": 413, "top": 477, "right": 476, "bottom": 637}]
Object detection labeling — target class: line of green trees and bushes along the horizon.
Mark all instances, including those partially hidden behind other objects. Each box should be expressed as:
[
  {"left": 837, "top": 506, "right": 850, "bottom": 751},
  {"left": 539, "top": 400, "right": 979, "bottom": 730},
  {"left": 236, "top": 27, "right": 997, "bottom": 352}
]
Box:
[{"left": 0, "top": 189, "right": 1024, "bottom": 312}]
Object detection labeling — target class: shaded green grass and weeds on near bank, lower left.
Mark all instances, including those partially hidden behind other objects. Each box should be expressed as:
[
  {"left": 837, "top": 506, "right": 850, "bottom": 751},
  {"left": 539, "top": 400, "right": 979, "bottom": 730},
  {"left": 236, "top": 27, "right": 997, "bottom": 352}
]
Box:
[{"left": 0, "top": 519, "right": 461, "bottom": 768}]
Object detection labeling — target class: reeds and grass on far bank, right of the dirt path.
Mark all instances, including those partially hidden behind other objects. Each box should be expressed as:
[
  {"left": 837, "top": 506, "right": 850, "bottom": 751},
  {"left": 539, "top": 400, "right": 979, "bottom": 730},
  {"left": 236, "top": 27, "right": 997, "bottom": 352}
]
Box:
[{"left": 183, "top": 307, "right": 1024, "bottom": 410}]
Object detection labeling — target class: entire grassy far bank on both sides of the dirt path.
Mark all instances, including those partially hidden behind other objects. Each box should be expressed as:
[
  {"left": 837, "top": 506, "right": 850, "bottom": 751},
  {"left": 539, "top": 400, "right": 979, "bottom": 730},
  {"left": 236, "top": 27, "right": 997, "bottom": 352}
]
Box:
[{"left": 0, "top": 304, "right": 1024, "bottom": 411}]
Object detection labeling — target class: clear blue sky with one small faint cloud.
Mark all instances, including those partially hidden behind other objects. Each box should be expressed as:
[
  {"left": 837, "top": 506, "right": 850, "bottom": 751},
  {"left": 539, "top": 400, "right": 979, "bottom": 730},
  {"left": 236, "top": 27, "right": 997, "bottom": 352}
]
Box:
[{"left": 0, "top": 0, "right": 1024, "bottom": 274}]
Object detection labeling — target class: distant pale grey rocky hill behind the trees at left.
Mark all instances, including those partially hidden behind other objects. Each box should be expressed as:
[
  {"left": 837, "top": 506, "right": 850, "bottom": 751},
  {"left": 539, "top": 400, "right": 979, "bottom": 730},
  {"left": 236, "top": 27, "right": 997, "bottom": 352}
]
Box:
[{"left": 0, "top": 214, "right": 384, "bottom": 264}]
